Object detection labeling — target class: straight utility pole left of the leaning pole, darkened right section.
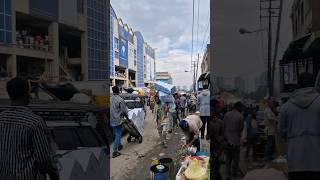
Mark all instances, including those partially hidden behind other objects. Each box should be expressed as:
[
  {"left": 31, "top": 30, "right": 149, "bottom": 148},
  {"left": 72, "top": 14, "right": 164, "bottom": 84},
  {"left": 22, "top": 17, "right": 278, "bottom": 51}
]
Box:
[{"left": 268, "top": 0, "right": 273, "bottom": 96}]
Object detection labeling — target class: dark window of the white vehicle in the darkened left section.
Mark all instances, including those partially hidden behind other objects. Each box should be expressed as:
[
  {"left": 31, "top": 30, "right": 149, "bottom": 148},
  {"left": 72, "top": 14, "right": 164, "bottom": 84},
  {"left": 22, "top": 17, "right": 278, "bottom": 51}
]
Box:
[{"left": 53, "top": 127, "right": 80, "bottom": 150}]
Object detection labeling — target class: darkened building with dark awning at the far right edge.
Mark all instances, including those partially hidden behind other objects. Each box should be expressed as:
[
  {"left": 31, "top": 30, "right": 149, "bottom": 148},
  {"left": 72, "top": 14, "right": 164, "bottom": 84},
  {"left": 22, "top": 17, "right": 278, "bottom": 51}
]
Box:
[{"left": 280, "top": 0, "right": 320, "bottom": 93}]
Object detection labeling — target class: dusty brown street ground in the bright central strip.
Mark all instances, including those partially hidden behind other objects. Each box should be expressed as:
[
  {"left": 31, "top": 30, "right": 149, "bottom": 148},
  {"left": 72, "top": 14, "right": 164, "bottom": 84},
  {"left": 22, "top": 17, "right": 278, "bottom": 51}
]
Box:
[{"left": 110, "top": 111, "right": 209, "bottom": 180}]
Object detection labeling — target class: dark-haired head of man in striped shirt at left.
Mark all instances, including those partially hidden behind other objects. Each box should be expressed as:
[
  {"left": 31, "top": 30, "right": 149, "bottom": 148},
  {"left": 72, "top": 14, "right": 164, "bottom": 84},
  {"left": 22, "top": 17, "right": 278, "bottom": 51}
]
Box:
[{"left": 7, "top": 77, "right": 31, "bottom": 105}]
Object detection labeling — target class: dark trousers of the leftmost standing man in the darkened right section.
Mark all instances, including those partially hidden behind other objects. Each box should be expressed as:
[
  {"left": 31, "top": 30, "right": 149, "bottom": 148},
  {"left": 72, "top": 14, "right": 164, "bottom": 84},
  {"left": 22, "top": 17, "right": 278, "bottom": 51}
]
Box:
[{"left": 225, "top": 145, "right": 240, "bottom": 177}]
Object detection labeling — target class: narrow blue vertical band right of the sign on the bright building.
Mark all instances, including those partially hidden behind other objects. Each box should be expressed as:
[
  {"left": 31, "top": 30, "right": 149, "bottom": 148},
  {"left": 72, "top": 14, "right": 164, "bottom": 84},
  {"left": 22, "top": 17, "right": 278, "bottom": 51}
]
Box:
[{"left": 135, "top": 32, "right": 144, "bottom": 87}]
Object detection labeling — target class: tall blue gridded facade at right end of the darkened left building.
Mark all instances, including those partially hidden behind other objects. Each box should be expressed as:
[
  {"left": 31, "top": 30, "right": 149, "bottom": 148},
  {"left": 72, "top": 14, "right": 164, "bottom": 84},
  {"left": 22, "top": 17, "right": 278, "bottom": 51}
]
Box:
[{"left": 87, "top": 0, "right": 109, "bottom": 80}]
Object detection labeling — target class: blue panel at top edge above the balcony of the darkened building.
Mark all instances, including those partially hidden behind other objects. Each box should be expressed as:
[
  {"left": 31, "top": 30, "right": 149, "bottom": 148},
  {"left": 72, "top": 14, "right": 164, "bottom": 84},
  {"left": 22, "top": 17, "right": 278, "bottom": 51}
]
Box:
[{"left": 30, "top": 0, "right": 58, "bottom": 21}]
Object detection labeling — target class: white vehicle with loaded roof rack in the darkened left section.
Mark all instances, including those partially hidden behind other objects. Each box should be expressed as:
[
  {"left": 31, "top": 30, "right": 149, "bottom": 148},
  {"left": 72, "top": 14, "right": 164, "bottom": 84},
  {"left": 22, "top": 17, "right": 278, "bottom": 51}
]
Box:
[{"left": 0, "top": 84, "right": 111, "bottom": 180}]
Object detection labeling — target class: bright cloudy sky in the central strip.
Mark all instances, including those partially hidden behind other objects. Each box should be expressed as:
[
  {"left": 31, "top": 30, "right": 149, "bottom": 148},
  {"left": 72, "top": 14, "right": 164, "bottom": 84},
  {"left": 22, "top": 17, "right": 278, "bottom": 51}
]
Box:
[{"left": 110, "top": 0, "right": 210, "bottom": 87}]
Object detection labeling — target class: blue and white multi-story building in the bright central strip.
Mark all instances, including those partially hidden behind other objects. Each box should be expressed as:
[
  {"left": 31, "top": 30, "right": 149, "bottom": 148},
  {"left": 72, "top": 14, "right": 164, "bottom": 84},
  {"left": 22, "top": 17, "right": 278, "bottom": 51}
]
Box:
[{"left": 109, "top": 7, "right": 155, "bottom": 87}]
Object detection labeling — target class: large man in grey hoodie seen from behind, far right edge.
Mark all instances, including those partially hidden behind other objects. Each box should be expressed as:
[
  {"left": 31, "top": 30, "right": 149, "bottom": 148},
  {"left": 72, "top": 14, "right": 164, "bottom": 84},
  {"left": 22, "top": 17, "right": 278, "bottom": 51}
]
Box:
[{"left": 279, "top": 73, "right": 320, "bottom": 180}]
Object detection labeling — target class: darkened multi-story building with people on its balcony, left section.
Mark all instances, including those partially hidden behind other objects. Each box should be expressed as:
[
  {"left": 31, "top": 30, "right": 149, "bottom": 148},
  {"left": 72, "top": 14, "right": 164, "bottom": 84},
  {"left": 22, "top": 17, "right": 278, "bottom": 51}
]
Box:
[{"left": 0, "top": 0, "right": 109, "bottom": 82}]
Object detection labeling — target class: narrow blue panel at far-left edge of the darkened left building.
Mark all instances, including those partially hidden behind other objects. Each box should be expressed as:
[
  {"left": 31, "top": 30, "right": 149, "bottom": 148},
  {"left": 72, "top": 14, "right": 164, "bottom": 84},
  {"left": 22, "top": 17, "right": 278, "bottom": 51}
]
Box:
[{"left": 0, "top": 0, "right": 12, "bottom": 44}]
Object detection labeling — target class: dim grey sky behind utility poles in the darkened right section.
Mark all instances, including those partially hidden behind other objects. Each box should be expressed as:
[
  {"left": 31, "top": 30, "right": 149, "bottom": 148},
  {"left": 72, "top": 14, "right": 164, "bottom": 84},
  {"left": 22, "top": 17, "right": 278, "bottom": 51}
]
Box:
[{"left": 213, "top": 0, "right": 292, "bottom": 91}]
